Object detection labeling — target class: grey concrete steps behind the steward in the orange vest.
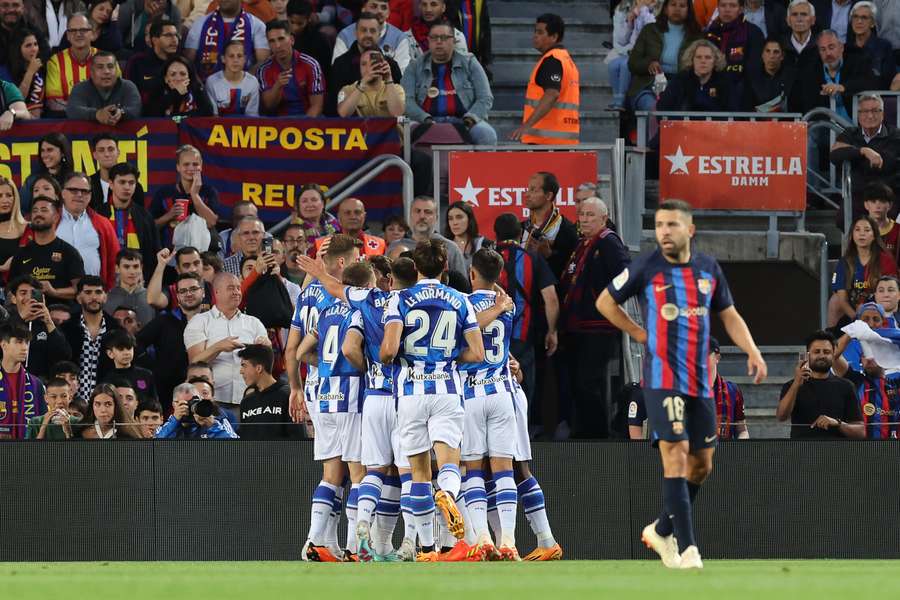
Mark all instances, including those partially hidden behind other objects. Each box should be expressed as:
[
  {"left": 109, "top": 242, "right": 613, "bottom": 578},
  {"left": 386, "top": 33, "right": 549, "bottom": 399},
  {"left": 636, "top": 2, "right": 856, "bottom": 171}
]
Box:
[{"left": 490, "top": 0, "right": 619, "bottom": 143}]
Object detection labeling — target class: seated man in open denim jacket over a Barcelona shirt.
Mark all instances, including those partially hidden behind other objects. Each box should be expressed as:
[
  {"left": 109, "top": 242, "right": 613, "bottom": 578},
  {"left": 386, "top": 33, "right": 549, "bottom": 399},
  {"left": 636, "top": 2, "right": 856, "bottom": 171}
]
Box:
[{"left": 400, "top": 22, "right": 497, "bottom": 146}]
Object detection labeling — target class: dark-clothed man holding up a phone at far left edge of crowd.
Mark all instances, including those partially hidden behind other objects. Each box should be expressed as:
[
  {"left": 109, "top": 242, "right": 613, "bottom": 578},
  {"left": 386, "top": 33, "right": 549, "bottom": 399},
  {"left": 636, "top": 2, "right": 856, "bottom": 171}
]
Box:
[{"left": 6, "top": 275, "right": 72, "bottom": 378}]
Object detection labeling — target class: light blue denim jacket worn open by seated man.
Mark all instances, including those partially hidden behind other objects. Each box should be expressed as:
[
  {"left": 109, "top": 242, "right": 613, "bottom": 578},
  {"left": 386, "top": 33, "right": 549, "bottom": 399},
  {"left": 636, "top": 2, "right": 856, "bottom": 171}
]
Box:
[{"left": 400, "top": 52, "right": 494, "bottom": 122}]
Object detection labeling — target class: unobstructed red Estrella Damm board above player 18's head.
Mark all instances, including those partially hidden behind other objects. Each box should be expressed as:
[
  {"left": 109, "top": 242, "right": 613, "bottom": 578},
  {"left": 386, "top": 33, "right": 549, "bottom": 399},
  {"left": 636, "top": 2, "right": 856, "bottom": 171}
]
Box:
[{"left": 659, "top": 121, "right": 806, "bottom": 211}]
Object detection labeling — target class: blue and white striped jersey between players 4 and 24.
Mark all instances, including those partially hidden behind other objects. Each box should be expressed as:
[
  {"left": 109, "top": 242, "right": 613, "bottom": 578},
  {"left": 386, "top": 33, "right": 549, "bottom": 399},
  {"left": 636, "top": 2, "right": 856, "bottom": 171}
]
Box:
[{"left": 344, "top": 287, "right": 397, "bottom": 396}]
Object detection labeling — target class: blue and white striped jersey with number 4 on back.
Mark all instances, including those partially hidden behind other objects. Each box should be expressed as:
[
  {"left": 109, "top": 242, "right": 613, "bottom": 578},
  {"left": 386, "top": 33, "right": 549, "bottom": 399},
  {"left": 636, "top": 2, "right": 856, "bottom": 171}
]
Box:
[{"left": 315, "top": 302, "right": 365, "bottom": 413}]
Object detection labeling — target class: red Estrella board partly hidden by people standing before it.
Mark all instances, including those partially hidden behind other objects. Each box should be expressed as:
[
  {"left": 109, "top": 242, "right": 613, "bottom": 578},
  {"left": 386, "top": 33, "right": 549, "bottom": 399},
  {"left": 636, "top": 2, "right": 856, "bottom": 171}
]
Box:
[{"left": 449, "top": 151, "right": 597, "bottom": 236}]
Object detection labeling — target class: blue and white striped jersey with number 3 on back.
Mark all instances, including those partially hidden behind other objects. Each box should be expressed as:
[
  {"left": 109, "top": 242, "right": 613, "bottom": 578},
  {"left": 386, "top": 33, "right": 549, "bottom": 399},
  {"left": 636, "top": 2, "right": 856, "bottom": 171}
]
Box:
[{"left": 460, "top": 290, "right": 516, "bottom": 399}]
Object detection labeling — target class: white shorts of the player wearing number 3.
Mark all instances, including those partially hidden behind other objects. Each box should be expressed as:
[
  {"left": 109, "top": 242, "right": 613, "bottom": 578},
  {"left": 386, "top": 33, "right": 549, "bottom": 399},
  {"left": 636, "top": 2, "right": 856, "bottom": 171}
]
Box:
[{"left": 462, "top": 392, "right": 516, "bottom": 460}]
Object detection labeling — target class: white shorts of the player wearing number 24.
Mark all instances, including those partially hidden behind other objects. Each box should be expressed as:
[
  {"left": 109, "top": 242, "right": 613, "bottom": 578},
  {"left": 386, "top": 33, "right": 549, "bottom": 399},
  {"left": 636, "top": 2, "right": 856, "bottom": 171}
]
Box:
[{"left": 397, "top": 394, "right": 465, "bottom": 457}]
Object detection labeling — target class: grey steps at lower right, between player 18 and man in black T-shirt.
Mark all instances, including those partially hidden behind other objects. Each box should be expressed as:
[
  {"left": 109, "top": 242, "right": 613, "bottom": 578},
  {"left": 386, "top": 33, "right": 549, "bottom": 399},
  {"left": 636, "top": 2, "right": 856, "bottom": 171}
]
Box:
[{"left": 719, "top": 346, "right": 805, "bottom": 438}]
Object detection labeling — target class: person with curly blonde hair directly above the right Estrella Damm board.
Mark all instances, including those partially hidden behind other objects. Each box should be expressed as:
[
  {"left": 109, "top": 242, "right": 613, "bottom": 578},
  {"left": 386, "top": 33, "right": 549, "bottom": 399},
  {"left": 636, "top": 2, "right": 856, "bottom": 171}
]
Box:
[{"left": 656, "top": 40, "right": 742, "bottom": 112}]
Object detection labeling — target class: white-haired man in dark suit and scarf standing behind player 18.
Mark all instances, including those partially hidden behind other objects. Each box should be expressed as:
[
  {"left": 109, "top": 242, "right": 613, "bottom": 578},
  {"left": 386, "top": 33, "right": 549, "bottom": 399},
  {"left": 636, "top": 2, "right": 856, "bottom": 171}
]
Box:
[{"left": 559, "top": 197, "right": 631, "bottom": 438}]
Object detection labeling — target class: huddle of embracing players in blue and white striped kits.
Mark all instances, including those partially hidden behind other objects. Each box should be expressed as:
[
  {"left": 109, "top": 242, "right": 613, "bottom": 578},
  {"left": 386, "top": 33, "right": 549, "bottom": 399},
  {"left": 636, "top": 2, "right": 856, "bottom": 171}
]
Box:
[{"left": 285, "top": 234, "right": 562, "bottom": 562}]
